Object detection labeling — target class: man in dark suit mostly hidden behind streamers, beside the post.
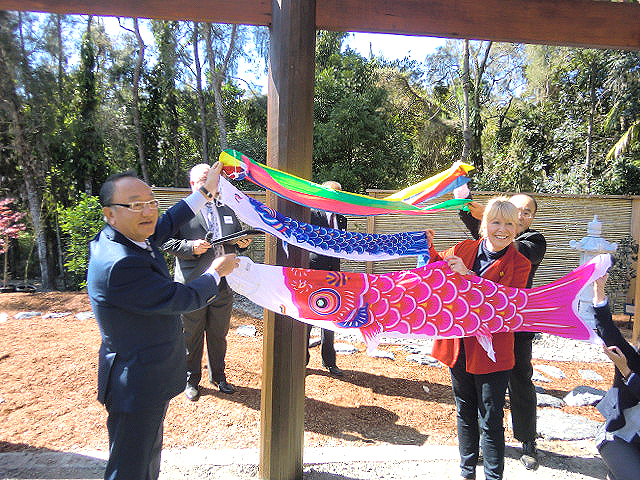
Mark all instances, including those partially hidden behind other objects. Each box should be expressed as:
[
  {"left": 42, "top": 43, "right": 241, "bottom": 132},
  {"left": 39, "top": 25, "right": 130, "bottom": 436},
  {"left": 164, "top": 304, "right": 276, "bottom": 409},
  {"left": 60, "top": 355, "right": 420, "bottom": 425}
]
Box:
[{"left": 307, "top": 180, "right": 347, "bottom": 377}]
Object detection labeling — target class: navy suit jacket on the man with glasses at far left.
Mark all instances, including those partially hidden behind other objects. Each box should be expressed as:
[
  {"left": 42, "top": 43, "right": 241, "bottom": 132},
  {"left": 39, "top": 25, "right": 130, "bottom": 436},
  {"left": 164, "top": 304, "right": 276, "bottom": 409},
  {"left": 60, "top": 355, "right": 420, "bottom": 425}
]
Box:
[{"left": 87, "top": 201, "right": 218, "bottom": 412}]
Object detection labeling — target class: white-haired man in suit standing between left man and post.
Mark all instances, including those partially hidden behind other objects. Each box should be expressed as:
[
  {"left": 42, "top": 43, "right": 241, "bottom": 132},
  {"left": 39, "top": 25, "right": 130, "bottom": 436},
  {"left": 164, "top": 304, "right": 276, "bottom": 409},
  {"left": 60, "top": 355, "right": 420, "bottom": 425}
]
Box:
[{"left": 162, "top": 164, "right": 251, "bottom": 402}]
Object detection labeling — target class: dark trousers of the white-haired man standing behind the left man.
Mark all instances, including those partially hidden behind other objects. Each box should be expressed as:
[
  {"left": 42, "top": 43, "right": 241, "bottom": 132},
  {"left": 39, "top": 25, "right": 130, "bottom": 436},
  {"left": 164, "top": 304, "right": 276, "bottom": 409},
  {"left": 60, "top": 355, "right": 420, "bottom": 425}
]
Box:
[{"left": 182, "top": 281, "right": 233, "bottom": 387}]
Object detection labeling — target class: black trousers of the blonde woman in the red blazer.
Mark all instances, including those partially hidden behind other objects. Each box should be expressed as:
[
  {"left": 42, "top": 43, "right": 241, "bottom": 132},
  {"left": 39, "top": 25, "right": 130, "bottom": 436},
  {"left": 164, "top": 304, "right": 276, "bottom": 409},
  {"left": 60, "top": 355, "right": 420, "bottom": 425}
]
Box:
[{"left": 450, "top": 350, "right": 509, "bottom": 480}]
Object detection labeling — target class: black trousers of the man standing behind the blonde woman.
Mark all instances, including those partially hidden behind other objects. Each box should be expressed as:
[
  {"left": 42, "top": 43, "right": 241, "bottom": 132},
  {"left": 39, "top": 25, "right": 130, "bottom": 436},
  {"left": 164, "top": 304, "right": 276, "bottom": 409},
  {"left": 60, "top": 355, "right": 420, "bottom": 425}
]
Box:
[{"left": 509, "top": 332, "right": 538, "bottom": 442}]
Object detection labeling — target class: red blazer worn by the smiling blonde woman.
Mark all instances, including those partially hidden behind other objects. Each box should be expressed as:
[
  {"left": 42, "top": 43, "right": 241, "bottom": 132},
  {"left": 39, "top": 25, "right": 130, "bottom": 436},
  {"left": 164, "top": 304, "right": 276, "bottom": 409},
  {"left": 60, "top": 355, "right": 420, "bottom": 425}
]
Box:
[{"left": 431, "top": 238, "right": 531, "bottom": 374}]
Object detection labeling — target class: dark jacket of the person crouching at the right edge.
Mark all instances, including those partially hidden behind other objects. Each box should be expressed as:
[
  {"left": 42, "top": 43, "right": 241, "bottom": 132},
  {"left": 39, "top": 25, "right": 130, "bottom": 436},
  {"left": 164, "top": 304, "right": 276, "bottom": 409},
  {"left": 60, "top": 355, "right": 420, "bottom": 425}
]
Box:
[{"left": 595, "top": 304, "right": 640, "bottom": 432}]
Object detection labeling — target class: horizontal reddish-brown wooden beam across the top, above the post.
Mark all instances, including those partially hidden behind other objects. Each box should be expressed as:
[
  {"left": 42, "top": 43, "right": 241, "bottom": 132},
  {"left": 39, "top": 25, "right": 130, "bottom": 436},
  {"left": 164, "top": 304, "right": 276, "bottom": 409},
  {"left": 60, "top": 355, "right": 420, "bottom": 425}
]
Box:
[{"left": 0, "top": 0, "right": 640, "bottom": 49}]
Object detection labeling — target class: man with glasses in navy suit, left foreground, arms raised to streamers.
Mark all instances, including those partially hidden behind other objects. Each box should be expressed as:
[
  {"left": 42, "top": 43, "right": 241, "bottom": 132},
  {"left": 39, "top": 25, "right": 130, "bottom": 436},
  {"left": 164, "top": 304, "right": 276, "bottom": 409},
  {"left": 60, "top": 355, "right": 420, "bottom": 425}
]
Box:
[{"left": 87, "top": 164, "right": 238, "bottom": 480}]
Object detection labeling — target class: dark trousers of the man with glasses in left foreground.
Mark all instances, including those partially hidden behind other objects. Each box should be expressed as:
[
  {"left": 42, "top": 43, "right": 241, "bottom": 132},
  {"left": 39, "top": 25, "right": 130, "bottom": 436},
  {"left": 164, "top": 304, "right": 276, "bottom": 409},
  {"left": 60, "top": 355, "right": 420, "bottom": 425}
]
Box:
[{"left": 104, "top": 401, "right": 169, "bottom": 480}]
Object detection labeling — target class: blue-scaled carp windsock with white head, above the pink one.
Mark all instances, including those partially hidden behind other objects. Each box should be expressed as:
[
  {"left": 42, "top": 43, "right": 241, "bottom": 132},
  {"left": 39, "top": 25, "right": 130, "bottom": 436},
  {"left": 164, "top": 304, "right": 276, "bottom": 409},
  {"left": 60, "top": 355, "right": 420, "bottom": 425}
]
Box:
[{"left": 219, "top": 177, "right": 429, "bottom": 261}]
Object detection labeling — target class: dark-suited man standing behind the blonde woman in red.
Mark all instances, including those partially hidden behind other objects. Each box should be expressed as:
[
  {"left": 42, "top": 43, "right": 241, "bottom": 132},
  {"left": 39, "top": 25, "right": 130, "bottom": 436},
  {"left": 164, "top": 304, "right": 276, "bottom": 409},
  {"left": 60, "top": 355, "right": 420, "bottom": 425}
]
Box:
[{"left": 460, "top": 190, "right": 547, "bottom": 470}]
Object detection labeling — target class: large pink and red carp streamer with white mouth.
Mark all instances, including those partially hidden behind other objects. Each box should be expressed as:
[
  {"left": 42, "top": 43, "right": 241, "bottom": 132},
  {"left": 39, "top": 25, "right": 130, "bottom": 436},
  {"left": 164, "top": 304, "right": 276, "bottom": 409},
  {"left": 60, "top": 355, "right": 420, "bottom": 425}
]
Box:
[{"left": 226, "top": 255, "right": 611, "bottom": 361}]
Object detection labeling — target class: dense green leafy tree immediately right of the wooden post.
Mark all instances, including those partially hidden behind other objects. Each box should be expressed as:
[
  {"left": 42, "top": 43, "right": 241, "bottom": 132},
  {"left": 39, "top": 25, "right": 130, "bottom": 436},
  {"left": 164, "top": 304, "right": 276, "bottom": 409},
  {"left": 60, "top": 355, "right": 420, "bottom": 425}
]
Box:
[{"left": 313, "top": 32, "right": 412, "bottom": 192}]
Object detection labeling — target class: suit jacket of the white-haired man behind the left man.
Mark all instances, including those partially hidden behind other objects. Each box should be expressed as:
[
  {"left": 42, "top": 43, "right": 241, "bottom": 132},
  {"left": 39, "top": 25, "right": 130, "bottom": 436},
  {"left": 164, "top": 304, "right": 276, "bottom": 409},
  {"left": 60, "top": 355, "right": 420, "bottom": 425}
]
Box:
[{"left": 162, "top": 205, "right": 242, "bottom": 283}]
